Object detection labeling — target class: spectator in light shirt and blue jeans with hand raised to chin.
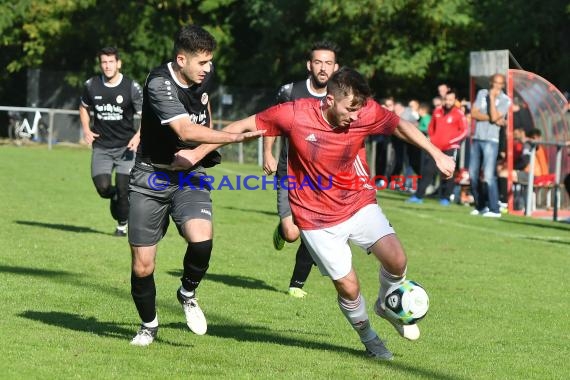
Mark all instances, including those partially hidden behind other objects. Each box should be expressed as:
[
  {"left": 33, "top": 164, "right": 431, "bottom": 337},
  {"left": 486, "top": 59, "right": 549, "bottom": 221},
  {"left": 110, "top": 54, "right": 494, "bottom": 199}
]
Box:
[{"left": 469, "top": 74, "right": 511, "bottom": 218}]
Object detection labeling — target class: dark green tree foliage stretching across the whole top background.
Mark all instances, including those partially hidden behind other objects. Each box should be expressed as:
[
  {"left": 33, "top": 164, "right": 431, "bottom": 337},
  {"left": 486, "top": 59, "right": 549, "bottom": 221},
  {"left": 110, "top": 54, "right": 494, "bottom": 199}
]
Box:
[{"left": 0, "top": 0, "right": 570, "bottom": 99}]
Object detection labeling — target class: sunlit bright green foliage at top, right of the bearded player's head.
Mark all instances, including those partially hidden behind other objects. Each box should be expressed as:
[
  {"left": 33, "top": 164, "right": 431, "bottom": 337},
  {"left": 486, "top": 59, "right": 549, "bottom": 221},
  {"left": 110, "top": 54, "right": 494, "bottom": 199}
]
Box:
[{"left": 302, "top": 0, "right": 473, "bottom": 96}]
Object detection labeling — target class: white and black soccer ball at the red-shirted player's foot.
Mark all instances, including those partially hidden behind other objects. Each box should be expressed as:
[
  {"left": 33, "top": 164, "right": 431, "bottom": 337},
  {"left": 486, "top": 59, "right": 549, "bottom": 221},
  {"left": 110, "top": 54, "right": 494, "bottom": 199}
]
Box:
[{"left": 384, "top": 280, "right": 429, "bottom": 325}]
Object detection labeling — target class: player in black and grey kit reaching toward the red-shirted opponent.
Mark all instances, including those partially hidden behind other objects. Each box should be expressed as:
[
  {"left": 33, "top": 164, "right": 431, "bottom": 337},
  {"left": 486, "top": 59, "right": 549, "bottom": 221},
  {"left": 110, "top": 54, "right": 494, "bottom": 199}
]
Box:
[{"left": 129, "top": 25, "right": 262, "bottom": 346}]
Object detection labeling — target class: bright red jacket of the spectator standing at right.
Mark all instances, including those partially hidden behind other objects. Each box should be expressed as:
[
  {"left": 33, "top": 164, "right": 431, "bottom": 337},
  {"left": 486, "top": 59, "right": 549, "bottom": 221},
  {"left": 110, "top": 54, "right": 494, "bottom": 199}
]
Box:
[{"left": 428, "top": 107, "right": 467, "bottom": 151}]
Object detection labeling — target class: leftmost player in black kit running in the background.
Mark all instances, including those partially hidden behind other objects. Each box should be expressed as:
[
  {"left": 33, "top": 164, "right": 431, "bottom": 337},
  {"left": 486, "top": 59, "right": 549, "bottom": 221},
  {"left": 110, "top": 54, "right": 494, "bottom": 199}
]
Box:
[{"left": 79, "top": 47, "right": 142, "bottom": 236}]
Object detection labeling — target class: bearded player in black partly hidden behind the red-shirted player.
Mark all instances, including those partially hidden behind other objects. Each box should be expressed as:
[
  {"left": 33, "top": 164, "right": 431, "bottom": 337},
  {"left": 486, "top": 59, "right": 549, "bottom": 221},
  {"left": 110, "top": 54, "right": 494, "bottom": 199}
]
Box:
[{"left": 263, "top": 41, "right": 339, "bottom": 298}]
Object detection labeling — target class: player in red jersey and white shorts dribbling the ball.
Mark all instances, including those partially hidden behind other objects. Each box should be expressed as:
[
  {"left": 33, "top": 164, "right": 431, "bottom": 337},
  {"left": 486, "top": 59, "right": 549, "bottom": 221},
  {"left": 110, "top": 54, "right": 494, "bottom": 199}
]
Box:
[{"left": 176, "top": 68, "right": 455, "bottom": 360}]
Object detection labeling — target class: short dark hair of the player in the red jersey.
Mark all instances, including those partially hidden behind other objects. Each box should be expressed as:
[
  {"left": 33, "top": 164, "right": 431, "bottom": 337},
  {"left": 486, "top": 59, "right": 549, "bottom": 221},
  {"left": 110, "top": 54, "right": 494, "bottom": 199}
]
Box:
[{"left": 327, "top": 67, "right": 372, "bottom": 106}]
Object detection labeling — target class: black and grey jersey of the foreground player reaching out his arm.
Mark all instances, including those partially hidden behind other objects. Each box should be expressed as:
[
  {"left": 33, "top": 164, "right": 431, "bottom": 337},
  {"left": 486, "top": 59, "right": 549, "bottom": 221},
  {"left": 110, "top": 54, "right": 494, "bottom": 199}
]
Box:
[{"left": 137, "top": 62, "right": 214, "bottom": 165}]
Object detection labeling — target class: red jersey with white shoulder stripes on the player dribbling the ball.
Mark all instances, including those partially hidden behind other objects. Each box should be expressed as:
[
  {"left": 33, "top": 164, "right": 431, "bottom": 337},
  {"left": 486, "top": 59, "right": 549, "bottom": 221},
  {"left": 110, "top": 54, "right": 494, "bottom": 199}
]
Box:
[{"left": 256, "top": 99, "right": 400, "bottom": 230}]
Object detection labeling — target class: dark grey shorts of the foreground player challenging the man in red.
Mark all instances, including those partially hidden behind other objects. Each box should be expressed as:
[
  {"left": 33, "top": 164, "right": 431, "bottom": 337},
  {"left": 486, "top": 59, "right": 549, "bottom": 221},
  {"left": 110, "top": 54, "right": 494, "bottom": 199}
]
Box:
[{"left": 128, "top": 162, "right": 212, "bottom": 246}]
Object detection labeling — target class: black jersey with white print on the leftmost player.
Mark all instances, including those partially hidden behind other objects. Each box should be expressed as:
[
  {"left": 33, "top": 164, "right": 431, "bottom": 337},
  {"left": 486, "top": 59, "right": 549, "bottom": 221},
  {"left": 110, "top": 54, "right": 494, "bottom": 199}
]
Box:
[{"left": 81, "top": 74, "right": 143, "bottom": 148}]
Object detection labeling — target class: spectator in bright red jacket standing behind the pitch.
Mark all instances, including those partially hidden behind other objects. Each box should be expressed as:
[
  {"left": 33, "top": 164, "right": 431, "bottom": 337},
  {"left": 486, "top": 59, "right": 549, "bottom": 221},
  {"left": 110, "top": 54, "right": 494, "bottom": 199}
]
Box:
[{"left": 407, "top": 90, "right": 467, "bottom": 206}]
